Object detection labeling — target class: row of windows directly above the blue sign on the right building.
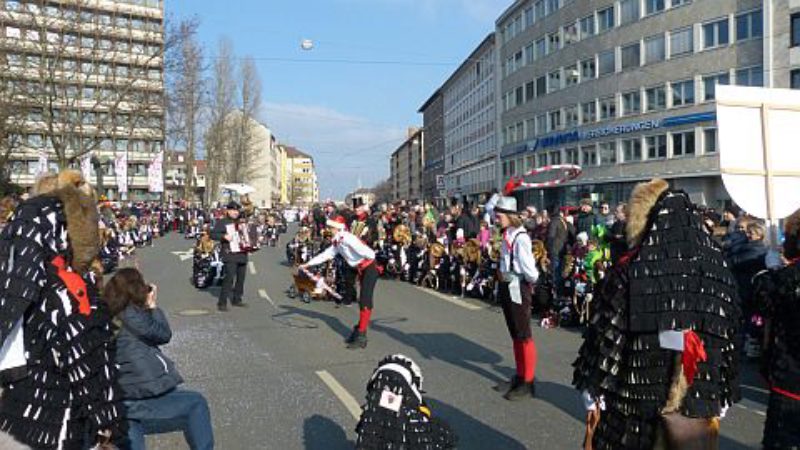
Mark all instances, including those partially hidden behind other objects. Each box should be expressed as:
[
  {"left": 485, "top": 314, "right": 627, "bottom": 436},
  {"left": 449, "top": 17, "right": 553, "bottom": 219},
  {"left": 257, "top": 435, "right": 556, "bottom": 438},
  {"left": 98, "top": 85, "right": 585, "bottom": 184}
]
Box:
[{"left": 501, "top": 66, "right": 763, "bottom": 145}]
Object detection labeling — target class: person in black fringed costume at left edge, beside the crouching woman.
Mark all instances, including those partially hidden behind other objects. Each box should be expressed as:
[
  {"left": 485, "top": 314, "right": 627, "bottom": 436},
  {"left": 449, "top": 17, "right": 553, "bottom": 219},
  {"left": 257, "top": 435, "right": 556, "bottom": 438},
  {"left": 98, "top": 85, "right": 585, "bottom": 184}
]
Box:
[{"left": 0, "top": 171, "right": 125, "bottom": 450}]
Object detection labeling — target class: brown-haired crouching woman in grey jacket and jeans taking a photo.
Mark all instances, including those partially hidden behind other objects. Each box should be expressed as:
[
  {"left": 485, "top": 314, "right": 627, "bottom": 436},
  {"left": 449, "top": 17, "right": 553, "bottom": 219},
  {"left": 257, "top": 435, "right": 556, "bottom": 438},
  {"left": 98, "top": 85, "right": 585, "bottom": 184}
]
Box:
[{"left": 104, "top": 268, "right": 214, "bottom": 450}]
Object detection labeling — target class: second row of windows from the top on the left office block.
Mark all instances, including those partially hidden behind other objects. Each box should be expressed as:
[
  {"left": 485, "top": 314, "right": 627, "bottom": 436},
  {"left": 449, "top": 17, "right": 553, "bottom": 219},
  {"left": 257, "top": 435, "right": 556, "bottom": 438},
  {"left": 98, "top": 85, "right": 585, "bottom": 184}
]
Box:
[{"left": 5, "top": 26, "right": 161, "bottom": 56}]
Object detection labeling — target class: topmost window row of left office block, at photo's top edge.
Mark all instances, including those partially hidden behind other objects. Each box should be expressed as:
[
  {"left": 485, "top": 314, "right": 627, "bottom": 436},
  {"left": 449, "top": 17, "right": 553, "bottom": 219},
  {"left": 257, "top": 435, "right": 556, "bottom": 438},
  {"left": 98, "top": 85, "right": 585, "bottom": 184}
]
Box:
[{"left": 5, "top": 0, "right": 161, "bottom": 31}]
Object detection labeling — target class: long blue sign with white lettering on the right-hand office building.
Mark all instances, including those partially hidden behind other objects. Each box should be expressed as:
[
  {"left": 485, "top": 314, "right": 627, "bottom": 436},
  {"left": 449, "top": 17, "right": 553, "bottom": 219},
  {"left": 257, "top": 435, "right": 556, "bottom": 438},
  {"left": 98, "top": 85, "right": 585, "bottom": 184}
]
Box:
[{"left": 500, "top": 111, "right": 717, "bottom": 158}]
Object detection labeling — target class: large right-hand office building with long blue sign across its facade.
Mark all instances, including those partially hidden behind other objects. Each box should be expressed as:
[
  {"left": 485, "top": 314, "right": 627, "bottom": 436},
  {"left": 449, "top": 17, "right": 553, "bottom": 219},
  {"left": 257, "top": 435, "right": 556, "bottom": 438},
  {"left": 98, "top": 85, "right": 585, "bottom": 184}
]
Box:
[{"left": 496, "top": 0, "right": 800, "bottom": 207}]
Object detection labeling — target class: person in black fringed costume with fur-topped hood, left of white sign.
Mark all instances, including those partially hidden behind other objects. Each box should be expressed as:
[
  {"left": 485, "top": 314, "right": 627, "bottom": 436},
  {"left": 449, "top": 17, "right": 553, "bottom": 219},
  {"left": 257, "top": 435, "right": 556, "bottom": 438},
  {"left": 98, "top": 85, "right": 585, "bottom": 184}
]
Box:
[{"left": 573, "top": 179, "right": 740, "bottom": 450}]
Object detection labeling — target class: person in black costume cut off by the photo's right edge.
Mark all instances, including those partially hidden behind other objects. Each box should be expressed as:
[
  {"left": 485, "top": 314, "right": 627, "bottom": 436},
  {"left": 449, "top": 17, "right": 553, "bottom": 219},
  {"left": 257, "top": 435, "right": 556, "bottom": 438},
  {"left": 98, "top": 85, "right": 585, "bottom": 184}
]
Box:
[{"left": 755, "top": 210, "right": 800, "bottom": 450}]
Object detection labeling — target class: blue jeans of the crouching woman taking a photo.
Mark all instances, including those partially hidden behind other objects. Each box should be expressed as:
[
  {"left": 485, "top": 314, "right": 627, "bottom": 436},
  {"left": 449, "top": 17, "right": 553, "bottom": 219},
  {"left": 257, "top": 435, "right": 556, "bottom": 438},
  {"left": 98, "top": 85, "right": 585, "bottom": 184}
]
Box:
[{"left": 124, "top": 389, "right": 214, "bottom": 450}]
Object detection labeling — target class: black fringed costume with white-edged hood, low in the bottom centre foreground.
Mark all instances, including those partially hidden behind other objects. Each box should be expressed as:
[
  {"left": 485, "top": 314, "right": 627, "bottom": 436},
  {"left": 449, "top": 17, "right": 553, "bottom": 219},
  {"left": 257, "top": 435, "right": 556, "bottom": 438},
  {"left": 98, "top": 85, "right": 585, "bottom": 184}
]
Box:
[{"left": 356, "top": 355, "right": 457, "bottom": 450}]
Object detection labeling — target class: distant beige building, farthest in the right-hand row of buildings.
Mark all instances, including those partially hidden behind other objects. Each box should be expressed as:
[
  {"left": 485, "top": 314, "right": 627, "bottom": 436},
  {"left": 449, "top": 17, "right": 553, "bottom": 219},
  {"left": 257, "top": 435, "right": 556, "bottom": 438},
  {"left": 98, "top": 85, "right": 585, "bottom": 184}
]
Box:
[{"left": 389, "top": 127, "right": 425, "bottom": 202}]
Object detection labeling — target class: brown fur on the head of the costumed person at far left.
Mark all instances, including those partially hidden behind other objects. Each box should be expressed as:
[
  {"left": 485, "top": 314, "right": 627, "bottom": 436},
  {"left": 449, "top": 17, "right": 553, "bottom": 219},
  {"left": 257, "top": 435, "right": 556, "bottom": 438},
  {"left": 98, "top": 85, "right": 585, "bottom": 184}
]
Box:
[{"left": 33, "top": 170, "right": 100, "bottom": 275}]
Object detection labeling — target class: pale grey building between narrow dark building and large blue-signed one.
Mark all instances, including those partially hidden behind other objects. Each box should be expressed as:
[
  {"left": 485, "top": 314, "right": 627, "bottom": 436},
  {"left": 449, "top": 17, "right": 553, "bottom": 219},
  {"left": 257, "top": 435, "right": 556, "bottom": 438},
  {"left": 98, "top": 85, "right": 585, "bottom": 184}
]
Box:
[{"left": 440, "top": 33, "right": 497, "bottom": 205}]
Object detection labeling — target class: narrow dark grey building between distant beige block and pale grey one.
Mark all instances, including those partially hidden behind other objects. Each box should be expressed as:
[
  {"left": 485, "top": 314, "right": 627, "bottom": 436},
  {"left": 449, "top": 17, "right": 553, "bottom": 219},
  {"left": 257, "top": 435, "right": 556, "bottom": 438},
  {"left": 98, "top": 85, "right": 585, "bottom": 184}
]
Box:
[{"left": 418, "top": 89, "right": 446, "bottom": 206}]
